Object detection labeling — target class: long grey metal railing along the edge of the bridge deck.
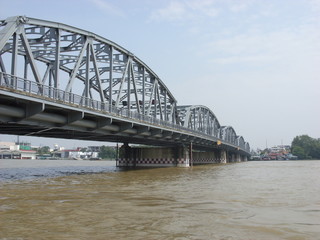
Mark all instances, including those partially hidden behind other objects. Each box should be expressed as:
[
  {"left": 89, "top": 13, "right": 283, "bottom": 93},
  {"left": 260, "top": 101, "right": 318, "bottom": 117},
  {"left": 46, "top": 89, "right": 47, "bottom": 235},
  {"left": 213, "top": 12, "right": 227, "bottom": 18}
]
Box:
[{"left": 0, "top": 72, "right": 247, "bottom": 151}]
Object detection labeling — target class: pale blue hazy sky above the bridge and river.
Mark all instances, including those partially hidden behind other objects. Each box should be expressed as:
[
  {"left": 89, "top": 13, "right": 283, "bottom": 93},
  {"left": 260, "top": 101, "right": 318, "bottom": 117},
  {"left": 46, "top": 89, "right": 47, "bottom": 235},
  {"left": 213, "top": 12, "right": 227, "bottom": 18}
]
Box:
[{"left": 0, "top": 0, "right": 320, "bottom": 149}]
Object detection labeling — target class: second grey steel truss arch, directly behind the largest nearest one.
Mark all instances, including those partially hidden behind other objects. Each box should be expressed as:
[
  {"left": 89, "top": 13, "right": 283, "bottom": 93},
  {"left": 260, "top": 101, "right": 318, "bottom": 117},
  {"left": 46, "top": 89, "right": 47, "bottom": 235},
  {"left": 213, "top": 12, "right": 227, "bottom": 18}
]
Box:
[{"left": 177, "top": 105, "right": 220, "bottom": 138}]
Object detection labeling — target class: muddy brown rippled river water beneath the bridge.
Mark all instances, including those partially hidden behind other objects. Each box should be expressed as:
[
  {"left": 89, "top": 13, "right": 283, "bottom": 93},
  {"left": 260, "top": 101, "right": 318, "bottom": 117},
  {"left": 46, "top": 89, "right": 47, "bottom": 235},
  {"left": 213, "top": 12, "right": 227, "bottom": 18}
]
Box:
[{"left": 0, "top": 160, "right": 320, "bottom": 240}]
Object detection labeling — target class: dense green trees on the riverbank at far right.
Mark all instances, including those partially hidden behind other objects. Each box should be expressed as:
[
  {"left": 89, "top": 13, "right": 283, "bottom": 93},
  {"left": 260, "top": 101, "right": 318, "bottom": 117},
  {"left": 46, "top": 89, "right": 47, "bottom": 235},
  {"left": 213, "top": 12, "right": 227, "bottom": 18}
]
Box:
[{"left": 291, "top": 135, "right": 320, "bottom": 159}]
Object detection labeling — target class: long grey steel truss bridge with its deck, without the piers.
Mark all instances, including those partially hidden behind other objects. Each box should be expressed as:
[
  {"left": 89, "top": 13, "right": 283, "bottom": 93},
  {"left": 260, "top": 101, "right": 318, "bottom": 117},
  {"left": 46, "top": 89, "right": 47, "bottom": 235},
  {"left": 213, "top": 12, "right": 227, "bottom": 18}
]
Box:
[{"left": 0, "top": 16, "right": 250, "bottom": 155}]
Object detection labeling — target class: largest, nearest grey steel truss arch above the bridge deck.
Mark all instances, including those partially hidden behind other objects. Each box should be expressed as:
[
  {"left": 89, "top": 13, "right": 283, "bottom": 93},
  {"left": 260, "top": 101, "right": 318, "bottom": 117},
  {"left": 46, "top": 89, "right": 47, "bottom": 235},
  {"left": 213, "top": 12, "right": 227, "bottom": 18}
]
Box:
[{"left": 0, "top": 16, "right": 177, "bottom": 123}]
